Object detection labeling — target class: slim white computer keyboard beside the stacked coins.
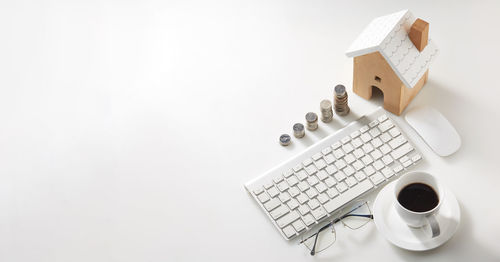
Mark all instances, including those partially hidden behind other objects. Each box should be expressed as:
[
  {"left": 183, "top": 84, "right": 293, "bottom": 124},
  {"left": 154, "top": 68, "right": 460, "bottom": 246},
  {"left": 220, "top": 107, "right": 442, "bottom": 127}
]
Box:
[{"left": 245, "top": 107, "right": 422, "bottom": 240}]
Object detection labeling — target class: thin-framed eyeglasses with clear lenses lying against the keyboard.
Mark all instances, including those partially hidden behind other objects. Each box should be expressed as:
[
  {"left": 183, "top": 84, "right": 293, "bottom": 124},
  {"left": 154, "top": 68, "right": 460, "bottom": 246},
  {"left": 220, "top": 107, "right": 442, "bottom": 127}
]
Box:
[{"left": 299, "top": 201, "right": 373, "bottom": 256}]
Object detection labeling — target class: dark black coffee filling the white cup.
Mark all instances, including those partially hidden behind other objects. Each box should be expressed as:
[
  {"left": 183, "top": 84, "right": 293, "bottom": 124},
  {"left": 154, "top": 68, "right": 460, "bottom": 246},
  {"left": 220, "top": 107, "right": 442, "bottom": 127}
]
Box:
[{"left": 398, "top": 183, "right": 439, "bottom": 212}]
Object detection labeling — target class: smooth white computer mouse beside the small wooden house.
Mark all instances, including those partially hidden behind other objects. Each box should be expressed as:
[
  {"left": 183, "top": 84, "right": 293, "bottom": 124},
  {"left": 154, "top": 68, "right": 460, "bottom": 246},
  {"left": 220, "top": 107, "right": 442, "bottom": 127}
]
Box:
[{"left": 405, "top": 106, "right": 462, "bottom": 156}]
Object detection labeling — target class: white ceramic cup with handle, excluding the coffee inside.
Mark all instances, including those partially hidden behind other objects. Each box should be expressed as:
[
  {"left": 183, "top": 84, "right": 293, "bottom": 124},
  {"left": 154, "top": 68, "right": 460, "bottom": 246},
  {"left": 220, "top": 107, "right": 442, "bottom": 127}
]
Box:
[{"left": 394, "top": 172, "right": 444, "bottom": 237}]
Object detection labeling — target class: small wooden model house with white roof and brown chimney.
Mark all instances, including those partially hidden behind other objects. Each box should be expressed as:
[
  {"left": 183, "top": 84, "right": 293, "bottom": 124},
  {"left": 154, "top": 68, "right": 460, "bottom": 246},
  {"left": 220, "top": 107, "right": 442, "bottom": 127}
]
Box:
[{"left": 346, "top": 10, "right": 438, "bottom": 115}]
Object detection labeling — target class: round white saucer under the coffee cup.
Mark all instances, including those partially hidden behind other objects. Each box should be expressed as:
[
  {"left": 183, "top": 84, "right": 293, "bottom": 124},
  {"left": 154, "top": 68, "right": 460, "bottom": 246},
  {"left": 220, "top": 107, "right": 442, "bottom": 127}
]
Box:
[{"left": 373, "top": 181, "right": 460, "bottom": 251}]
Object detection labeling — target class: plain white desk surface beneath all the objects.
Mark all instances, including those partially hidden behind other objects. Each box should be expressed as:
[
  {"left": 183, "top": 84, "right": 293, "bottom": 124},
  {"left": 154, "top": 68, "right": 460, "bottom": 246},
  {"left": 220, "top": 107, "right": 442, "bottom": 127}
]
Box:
[{"left": 0, "top": 0, "right": 500, "bottom": 262}]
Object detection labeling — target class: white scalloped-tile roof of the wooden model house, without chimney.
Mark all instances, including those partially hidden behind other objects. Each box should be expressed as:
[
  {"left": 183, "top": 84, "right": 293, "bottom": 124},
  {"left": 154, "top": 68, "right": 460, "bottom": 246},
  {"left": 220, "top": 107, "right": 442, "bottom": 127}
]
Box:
[{"left": 346, "top": 10, "right": 438, "bottom": 88}]
